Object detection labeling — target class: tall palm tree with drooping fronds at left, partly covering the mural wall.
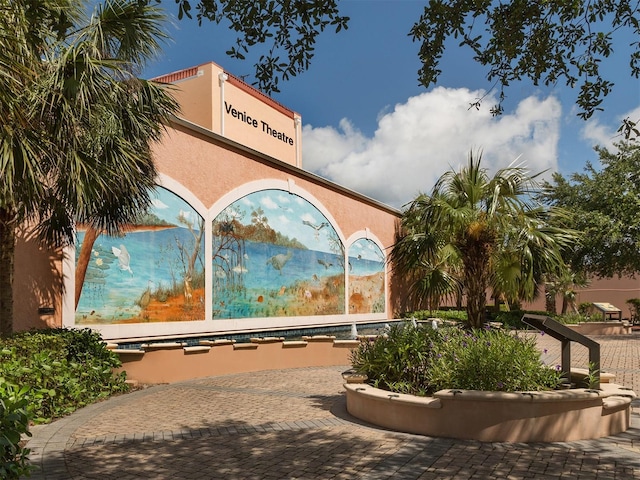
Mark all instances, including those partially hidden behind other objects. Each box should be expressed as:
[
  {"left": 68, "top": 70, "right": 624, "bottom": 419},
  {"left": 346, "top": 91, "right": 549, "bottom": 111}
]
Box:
[{"left": 0, "top": 0, "right": 177, "bottom": 334}]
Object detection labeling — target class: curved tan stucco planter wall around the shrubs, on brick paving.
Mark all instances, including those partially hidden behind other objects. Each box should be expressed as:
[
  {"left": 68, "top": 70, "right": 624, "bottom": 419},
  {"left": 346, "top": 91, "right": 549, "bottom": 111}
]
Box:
[{"left": 344, "top": 383, "right": 635, "bottom": 442}]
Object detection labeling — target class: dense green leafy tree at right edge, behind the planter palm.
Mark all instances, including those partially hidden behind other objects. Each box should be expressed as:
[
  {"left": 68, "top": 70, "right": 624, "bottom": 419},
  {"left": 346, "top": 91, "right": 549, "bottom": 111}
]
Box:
[{"left": 543, "top": 142, "right": 640, "bottom": 278}]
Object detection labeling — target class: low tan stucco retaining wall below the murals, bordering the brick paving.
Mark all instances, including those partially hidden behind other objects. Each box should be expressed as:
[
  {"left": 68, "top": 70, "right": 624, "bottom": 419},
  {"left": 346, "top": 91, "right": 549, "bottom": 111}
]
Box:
[{"left": 110, "top": 335, "right": 359, "bottom": 384}]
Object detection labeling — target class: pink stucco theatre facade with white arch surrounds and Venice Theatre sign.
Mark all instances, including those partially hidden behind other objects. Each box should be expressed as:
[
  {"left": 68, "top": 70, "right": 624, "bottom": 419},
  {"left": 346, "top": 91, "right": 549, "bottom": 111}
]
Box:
[{"left": 14, "top": 64, "right": 402, "bottom": 340}]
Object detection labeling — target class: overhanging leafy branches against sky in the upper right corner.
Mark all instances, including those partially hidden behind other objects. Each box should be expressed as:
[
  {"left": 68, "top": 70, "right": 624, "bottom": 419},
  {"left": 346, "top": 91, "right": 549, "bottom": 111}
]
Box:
[{"left": 411, "top": 0, "right": 640, "bottom": 126}]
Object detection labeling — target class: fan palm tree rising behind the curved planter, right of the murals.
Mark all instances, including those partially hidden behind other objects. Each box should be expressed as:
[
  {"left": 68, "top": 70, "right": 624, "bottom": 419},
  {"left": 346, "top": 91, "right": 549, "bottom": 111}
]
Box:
[{"left": 391, "top": 154, "right": 576, "bottom": 328}]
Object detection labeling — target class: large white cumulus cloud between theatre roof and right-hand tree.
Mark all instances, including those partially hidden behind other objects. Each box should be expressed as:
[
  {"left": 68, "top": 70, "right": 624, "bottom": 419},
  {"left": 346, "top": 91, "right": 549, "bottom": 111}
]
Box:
[{"left": 303, "top": 87, "right": 561, "bottom": 207}]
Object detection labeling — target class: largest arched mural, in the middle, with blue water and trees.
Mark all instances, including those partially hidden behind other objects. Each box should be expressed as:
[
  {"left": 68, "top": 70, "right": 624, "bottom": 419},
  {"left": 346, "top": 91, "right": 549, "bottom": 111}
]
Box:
[{"left": 212, "top": 189, "right": 345, "bottom": 319}]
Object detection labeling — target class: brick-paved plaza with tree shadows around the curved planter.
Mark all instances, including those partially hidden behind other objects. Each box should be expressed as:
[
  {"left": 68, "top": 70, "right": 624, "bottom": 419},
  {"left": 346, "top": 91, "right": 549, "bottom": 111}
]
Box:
[{"left": 28, "top": 334, "right": 640, "bottom": 480}]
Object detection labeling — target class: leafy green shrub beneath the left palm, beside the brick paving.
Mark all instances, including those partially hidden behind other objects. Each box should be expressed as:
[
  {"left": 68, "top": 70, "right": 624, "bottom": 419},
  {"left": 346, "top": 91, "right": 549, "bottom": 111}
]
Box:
[{"left": 0, "top": 329, "right": 128, "bottom": 423}]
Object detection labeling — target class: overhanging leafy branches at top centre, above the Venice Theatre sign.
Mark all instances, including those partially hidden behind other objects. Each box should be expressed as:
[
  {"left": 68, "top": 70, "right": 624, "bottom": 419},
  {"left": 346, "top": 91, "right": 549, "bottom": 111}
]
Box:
[{"left": 169, "top": 0, "right": 349, "bottom": 94}]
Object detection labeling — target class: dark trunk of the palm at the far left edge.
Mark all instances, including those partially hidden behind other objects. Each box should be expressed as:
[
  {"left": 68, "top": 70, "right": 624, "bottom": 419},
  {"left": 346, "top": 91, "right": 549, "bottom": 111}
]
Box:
[{"left": 0, "top": 208, "right": 16, "bottom": 336}]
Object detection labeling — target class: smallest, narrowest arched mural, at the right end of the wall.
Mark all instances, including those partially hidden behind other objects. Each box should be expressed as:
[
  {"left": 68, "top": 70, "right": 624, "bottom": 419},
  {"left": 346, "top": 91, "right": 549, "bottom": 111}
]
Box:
[{"left": 349, "top": 238, "right": 386, "bottom": 313}]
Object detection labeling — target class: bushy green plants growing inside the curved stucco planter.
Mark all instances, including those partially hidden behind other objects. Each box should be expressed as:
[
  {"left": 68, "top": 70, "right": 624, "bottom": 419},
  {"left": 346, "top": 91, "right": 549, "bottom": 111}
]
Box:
[{"left": 351, "top": 324, "right": 561, "bottom": 395}]
